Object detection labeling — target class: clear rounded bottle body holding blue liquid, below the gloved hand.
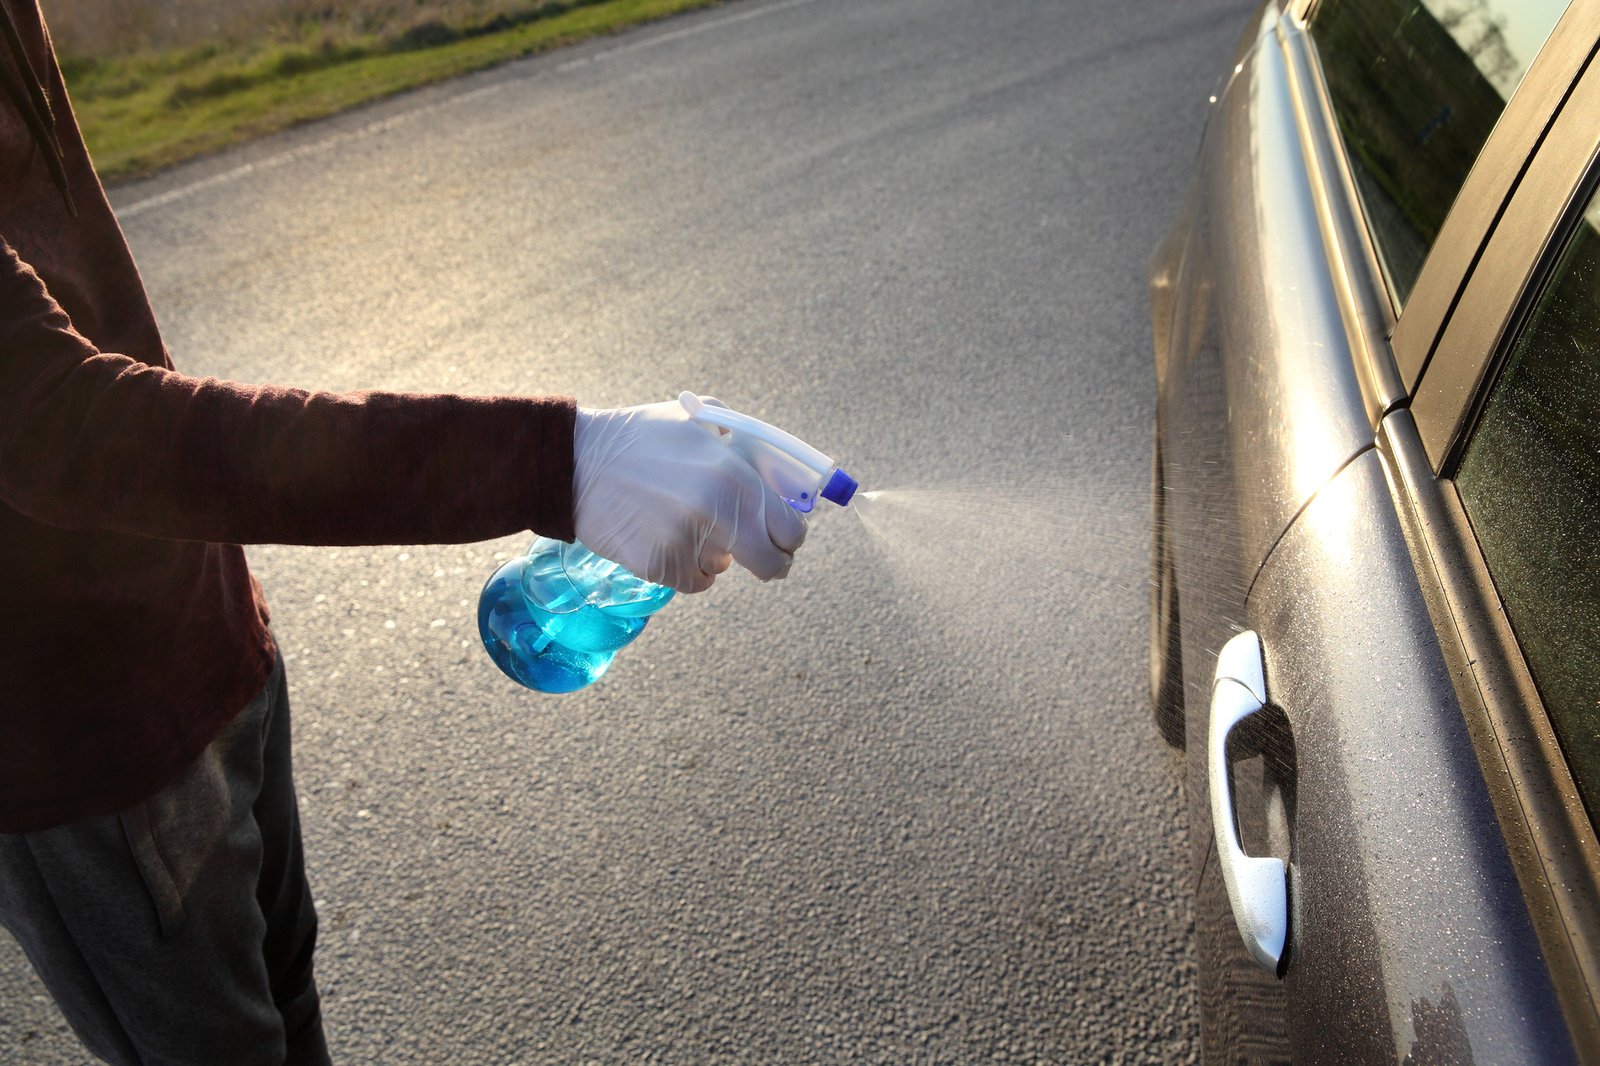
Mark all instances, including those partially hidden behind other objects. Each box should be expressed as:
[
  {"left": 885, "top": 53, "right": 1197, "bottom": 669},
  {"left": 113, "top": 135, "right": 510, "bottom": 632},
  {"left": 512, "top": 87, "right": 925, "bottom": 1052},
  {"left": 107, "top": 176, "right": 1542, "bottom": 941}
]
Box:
[{"left": 478, "top": 536, "right": 674, "bottom": 693}]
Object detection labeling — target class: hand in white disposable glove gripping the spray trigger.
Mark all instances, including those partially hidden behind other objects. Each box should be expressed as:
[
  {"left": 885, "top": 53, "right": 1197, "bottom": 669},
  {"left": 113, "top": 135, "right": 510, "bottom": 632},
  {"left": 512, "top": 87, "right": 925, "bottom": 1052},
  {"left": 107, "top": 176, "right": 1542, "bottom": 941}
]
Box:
[{"left": 573, "top": 399, "right": 806, "bottom": 592}]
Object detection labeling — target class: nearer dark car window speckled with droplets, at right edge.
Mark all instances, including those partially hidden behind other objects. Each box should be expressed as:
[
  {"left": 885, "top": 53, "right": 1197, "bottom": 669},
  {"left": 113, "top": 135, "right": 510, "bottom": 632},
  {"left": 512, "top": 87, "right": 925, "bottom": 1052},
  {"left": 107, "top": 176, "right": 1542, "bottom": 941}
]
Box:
[{"left": 1456, "top": 186, "right": 1600, "bottom": 824}]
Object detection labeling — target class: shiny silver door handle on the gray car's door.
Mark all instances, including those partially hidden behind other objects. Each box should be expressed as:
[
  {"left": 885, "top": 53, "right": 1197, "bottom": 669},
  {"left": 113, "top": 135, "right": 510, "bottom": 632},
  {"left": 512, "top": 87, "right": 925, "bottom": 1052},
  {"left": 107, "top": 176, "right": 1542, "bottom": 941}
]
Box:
[{"left": 1206, "top": 629, "right": 1290, "bottom": 973}]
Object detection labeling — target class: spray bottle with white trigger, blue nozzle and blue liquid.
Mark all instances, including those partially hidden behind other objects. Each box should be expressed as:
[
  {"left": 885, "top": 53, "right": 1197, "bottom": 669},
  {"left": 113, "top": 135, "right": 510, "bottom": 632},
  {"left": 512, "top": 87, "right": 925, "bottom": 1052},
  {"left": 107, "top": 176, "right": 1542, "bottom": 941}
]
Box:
[{"left": 478, "top": 392, "right": 856, "bottom": 693}]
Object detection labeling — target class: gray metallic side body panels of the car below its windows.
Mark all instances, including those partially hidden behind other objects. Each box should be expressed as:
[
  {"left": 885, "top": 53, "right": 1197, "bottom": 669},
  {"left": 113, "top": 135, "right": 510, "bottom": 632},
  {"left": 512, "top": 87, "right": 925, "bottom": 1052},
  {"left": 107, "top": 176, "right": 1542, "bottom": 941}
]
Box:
[{"left": 1150, "top": 3, "right": 1594, "bottom": 1063}]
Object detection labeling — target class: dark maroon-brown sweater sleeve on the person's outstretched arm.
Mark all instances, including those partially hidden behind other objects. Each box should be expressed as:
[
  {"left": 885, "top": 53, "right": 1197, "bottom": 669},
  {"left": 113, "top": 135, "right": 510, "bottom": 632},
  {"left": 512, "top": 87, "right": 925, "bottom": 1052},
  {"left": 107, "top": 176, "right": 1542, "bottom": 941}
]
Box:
[{"left": 0, "top": 238, "right": 574, "bottom": 544}]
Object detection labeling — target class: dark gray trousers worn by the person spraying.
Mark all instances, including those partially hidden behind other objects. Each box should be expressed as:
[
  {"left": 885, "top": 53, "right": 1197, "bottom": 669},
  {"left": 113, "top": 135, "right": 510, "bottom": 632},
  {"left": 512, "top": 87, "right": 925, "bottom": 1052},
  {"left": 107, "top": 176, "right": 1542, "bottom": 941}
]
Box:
[{"left": 0, "top": 659, "right": 330, "bottom": 1066}]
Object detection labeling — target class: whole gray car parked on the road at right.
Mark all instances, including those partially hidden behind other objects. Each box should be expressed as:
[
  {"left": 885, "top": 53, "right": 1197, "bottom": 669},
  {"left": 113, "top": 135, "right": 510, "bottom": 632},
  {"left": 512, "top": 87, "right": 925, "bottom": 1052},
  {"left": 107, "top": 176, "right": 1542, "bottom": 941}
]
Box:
[{"left": 1149, "top": 0, "right": 1600, "bottom": 1064}]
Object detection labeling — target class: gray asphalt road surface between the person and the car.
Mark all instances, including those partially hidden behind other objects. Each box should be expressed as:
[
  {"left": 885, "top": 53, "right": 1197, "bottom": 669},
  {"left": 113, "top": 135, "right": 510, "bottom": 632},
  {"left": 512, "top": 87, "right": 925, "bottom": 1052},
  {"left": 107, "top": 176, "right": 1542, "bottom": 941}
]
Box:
[{"left": 0, "top": 0, "right": 1250, "bottom": 1064}]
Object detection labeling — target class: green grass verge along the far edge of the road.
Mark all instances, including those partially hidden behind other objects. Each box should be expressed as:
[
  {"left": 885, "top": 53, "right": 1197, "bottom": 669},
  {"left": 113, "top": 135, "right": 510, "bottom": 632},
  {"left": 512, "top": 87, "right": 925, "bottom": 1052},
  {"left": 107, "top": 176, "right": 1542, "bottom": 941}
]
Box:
[{"left": 61, "top": 0, "right": 720, "bottom": 181}]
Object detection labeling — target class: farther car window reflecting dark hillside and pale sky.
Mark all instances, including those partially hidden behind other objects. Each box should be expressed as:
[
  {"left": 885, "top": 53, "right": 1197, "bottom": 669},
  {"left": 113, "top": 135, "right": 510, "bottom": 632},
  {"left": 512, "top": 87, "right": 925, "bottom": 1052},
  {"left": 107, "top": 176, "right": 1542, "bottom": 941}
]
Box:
[{"left": 1310, "top": 0, "right": 1568, "bottom": 306}]
